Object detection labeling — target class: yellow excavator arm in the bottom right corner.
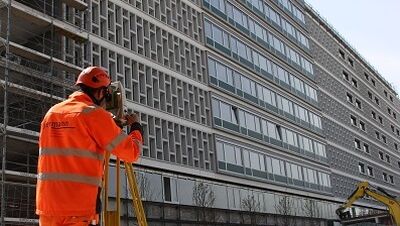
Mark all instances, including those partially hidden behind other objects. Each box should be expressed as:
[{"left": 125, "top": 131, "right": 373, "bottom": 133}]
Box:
[{"left": 336, "top": 181, "right": 400, "bottom": 226}]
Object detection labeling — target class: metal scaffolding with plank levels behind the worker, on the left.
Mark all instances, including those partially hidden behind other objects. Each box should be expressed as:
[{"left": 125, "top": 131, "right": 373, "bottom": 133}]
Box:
[{"left": 0, "top": 0, "right": 88, "bottom": 225}]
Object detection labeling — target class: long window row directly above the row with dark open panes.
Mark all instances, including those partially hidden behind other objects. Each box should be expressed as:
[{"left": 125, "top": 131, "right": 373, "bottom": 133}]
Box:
[{"left": 208, "top": 58, "right": 322, "bottom": 131}]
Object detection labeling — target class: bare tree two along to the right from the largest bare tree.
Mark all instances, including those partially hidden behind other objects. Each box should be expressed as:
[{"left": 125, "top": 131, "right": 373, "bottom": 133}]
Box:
[{"left": 275, "top": 196, "right": 296, "bottom": 226}]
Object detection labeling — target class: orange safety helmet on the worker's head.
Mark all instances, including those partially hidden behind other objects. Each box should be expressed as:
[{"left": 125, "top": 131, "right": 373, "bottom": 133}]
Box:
[{"left": 75, "top": 66, "right": 111, "bottom": 89}]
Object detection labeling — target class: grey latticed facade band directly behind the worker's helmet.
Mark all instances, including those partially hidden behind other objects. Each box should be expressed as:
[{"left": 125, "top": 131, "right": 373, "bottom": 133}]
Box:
[{"left": 88, "top": 43, "right": 211, "bottom": 125}]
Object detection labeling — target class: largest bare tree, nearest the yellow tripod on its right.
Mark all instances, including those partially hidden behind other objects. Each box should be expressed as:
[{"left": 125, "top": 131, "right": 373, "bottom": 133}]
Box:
[{"left": 193, "top": 182, "right": 215, "bottom": 207}]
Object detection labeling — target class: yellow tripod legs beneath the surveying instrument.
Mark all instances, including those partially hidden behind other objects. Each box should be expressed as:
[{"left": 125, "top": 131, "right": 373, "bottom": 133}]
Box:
[{"left": 102, "top": 154, "right": 147, "bottom": 226}]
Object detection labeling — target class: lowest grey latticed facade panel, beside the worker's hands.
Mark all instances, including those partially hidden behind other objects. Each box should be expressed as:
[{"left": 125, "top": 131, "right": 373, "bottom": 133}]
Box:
[{"left": 135, "top": 112, "right": 215, "bottom": 170}]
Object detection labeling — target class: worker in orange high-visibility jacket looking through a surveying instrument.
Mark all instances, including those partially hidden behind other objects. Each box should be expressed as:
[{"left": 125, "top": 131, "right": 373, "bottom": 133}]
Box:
[{"left": 36, "top": 67, "right": 142, "bottom": 226}]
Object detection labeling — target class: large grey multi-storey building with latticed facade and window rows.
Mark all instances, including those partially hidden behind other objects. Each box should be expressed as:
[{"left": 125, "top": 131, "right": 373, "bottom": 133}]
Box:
[{"left": 0, "top": 0, "right": 400, "bottom": 226}]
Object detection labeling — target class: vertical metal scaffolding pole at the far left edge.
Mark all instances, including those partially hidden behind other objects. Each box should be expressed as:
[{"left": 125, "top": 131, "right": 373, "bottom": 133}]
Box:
[{"left": 1, "top": 0, "right": 11, "bottom": 226}]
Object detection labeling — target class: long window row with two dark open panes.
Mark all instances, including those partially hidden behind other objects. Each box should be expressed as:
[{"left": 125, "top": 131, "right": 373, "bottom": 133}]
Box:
[{"left": 212, "top": 98, "right": 327, "bottom": 161}]
